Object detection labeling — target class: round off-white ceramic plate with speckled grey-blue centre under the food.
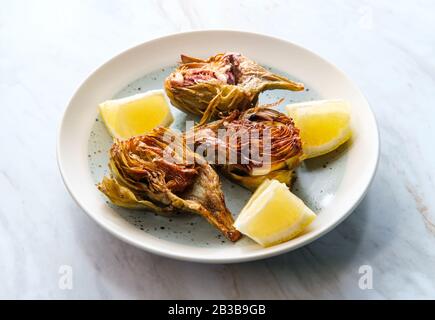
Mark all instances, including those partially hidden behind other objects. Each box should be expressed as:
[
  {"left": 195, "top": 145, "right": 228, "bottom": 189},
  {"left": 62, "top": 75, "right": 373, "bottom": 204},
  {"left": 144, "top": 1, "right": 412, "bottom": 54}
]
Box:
[{"left": 57, "top": 31, "right": 379, "bottom": 263}]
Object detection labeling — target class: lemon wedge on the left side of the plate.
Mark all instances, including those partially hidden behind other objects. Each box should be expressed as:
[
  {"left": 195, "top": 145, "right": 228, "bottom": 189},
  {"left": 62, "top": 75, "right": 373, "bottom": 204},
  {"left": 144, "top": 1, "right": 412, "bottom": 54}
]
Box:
[{"left": 99, "top": 90, "right": 174, "bottom": 139}]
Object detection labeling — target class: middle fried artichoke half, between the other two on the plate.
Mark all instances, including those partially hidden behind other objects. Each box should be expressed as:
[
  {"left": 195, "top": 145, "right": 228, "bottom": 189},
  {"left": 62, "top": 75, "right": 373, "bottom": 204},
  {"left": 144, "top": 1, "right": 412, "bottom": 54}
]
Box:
[{"left": 185, "top": 107, "right": 302, "bottom": 190}]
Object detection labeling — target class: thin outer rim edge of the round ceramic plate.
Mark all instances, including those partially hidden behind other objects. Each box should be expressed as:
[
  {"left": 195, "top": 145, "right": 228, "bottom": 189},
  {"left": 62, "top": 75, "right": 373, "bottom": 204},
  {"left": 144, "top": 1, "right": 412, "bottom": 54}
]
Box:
[{"left": 56, "top": 29, "right": 380, "bottom": 264}]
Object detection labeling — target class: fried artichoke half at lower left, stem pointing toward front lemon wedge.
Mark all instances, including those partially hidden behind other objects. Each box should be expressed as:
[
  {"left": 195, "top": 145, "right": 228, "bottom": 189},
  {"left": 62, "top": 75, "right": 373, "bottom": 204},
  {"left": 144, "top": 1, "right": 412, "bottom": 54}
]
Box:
[{"left": 97, "top": 127, "right": 241, "bottom": 241}]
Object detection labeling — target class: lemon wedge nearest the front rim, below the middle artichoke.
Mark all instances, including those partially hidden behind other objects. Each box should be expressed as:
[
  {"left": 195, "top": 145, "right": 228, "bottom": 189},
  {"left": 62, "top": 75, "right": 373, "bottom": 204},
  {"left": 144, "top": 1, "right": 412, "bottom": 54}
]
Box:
[{"left": 234, "top": 180, "right": 316, "bottom": 247}]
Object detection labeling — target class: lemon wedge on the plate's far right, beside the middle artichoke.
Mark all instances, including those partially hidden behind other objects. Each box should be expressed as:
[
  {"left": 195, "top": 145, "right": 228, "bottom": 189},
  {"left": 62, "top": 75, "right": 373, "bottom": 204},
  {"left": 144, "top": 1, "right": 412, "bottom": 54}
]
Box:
[{"left": 286, "top": 100, "right": 352, "bottom": 159}]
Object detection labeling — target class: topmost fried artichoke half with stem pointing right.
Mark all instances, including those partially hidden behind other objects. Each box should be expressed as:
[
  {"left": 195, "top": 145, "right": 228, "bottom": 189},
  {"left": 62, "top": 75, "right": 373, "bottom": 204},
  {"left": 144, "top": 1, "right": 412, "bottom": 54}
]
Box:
[{"left": 165, "top": 52, "right": 304, "bottom": 124}]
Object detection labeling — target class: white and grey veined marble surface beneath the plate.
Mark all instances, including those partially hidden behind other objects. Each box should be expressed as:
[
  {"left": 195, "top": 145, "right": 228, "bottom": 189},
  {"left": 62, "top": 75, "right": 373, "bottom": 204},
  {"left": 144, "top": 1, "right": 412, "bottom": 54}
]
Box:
[{"left": 0, "top": 0, "right": 435, "bottom": 299}]
